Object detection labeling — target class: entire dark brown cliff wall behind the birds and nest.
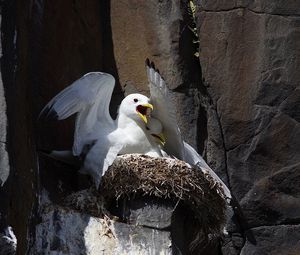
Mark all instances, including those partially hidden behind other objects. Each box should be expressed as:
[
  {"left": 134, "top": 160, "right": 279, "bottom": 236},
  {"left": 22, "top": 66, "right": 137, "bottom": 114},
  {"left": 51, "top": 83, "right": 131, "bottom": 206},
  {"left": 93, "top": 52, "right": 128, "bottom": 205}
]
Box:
[{"left": 0, "top": 0, "right": 300, "bottom": 254}]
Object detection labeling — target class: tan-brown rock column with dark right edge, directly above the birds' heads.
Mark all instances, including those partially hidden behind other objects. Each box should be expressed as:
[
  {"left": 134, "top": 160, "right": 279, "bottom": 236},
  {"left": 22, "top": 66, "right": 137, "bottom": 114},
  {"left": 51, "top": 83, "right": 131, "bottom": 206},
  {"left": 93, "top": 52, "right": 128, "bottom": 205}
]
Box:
[{"left": 110, "top": 0, "right": 201, "bottom": 146}]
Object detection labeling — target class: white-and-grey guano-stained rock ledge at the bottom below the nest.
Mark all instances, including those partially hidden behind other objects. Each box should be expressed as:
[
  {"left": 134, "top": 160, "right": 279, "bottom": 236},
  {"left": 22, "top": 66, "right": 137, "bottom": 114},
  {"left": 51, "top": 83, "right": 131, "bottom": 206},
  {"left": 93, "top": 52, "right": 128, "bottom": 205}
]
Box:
[{"left": 31, "top": 201, "right": 171, "bottom": 255}]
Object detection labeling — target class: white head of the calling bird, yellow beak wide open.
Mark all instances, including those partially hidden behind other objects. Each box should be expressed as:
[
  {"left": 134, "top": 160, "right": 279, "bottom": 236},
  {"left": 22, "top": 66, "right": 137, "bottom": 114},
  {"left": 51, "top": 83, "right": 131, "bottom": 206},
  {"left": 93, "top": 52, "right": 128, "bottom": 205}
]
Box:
[{"left": 119, "top": 94, "right": 153, "bottom": 123}]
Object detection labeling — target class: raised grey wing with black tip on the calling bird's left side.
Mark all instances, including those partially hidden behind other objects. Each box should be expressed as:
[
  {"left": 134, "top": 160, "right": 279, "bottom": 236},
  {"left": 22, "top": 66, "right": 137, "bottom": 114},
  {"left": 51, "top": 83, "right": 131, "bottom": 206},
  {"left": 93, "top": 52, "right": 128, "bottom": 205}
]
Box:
[{"left": 40, "top": 72, "right": 116, "bottom": 155}]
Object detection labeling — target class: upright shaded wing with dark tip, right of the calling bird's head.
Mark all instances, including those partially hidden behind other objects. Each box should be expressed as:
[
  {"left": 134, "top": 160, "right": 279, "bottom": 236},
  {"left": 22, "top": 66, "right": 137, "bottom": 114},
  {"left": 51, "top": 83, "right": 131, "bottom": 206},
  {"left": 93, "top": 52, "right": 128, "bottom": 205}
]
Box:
[{"left": 146, "top": 60, "right": 183, "bottom": 159}]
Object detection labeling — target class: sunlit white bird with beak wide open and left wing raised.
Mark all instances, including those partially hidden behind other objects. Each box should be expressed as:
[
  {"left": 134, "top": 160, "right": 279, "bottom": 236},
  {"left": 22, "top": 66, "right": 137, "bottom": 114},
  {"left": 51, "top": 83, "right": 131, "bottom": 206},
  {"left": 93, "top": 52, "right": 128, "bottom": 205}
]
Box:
[{"left": 40, "top": 72, "right": 162, "bottom": 187}]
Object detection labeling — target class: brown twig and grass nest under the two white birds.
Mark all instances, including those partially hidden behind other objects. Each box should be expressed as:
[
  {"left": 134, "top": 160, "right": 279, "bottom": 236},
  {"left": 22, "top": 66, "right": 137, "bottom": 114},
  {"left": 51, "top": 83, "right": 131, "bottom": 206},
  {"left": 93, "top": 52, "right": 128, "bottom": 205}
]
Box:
[{"left": 100, "top": 155, "right": 226, "bottom": 239}]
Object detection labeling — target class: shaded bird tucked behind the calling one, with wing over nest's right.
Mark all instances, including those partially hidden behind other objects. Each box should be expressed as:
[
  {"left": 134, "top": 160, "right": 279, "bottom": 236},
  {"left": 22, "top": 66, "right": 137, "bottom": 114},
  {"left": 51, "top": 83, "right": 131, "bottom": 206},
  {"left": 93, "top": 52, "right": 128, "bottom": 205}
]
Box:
[{"left": 146, "top": 60, "right": 231, "bottom": 200}]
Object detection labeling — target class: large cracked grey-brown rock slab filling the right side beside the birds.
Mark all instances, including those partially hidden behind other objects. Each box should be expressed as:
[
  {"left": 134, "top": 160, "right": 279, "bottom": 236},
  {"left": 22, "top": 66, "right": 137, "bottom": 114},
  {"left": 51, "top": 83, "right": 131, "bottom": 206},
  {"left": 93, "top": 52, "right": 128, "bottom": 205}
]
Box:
[{"left": 197, "top": 1, "right": 300, "bottom": 254}]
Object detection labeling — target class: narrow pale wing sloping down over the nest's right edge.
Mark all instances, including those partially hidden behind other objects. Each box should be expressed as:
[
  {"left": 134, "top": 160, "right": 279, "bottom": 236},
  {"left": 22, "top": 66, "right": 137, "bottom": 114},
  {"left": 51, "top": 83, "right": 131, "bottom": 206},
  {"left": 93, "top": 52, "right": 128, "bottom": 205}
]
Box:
[{"left": 184, "top": 142, "right": 231, "bottom": 199}]
